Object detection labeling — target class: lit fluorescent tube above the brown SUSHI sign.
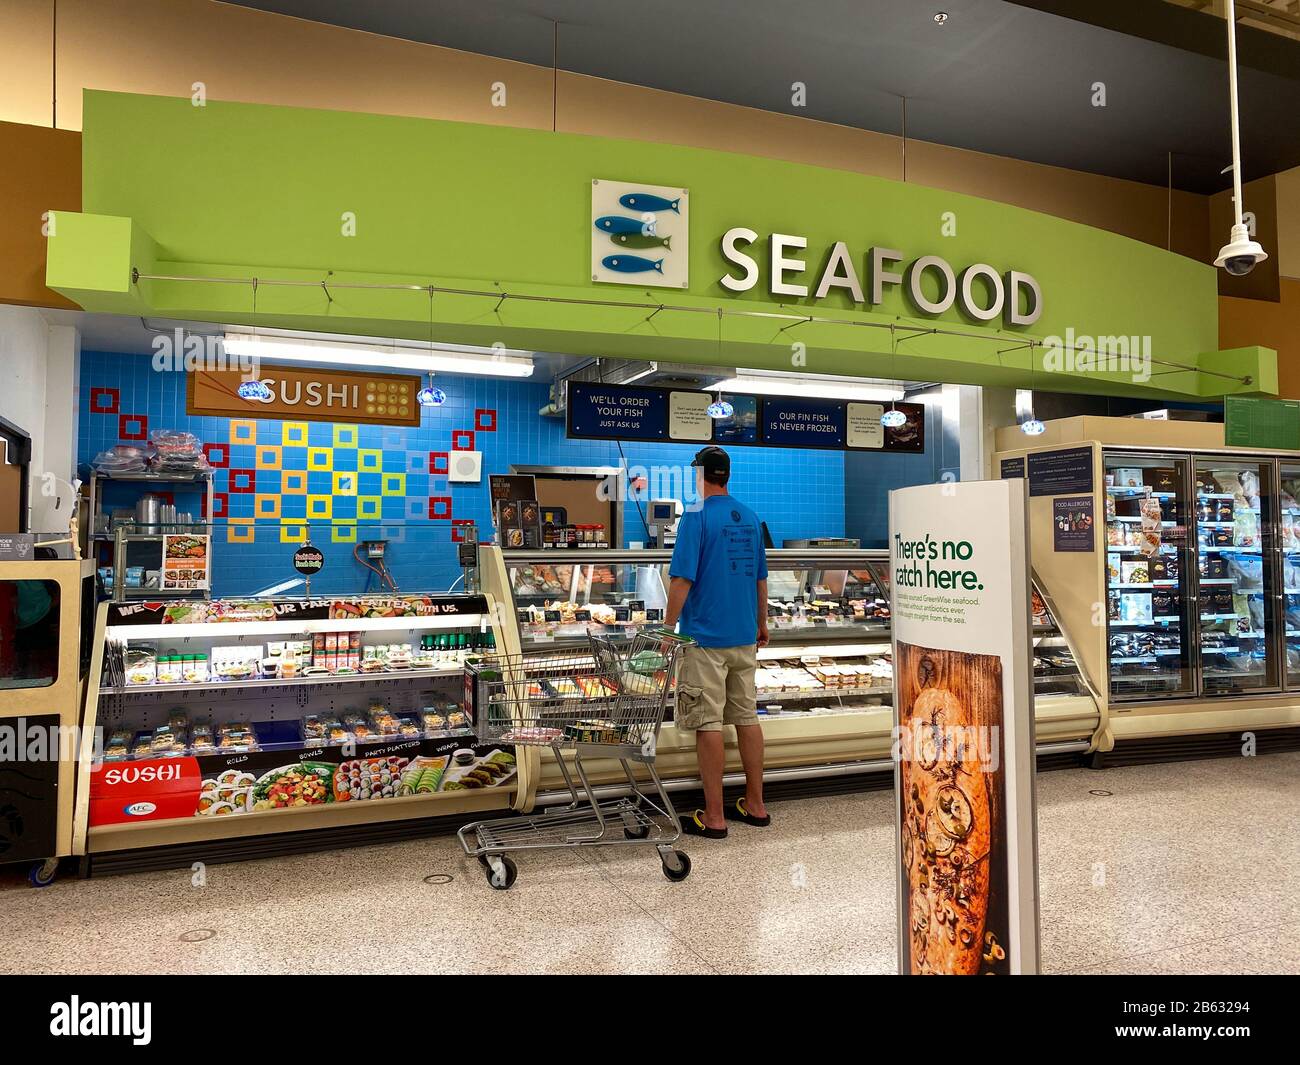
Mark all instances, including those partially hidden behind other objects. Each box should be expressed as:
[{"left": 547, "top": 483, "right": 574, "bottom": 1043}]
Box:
[{"left": 225, "top": 332, "right": 533, "bottom": 377}]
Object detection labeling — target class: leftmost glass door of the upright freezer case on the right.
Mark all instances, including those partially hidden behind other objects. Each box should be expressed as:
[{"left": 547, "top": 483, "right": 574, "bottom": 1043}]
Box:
[{"left": 1104, "top": 451, "right": 1196, "bottom": 700}]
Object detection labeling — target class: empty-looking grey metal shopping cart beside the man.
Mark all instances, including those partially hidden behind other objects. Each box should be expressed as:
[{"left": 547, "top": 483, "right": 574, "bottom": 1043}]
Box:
[{"left": 459, "top": 632, "right": 690, "bottom": 891}]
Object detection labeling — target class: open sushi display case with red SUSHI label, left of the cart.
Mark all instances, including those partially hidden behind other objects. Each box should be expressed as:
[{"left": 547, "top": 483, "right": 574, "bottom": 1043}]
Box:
[{"left": 85, "top": 596, "right": 521, "bottom": 849}]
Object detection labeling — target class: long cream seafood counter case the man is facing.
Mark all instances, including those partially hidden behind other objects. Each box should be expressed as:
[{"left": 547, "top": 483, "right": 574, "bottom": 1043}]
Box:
[{"left": 480, "top": 546, "right": 1100, "bottom": 797}]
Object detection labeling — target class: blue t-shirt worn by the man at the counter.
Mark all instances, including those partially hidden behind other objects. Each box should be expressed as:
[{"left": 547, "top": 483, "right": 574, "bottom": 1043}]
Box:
[{"left": 668, "top": 495, "right": 767, "bottom": 648}]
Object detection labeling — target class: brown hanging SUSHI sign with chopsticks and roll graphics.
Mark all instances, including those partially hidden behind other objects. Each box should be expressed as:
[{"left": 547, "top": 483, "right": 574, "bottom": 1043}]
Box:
[{"left": 186, "top": 365, "right": 421, "bottom": 425}]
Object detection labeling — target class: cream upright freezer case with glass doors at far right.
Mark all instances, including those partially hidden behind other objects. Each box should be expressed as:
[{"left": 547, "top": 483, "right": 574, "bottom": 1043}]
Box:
[{"left": 995, "top": 416, "right": 1300, "bottom": 763}]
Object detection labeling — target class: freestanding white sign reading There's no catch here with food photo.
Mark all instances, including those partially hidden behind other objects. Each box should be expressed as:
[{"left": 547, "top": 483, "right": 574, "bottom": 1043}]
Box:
[{"left": 889, "top": 480, "right": 1039, "bottom": 975}]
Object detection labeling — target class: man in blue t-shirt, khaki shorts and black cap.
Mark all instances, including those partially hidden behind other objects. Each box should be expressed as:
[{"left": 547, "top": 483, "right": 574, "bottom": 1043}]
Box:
[{"left": 664, "top": 447, "right": 772, "bottom": 839}]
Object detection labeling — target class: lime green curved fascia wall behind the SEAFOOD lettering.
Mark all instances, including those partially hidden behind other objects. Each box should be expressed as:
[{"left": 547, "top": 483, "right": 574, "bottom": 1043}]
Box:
[{"left": 48, "top": 92, "right": 1275, "bottom": 395}]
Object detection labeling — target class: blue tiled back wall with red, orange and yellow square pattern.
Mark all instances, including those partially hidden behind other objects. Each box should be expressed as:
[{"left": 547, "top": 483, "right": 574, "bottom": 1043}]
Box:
[{"left": 79, "top": 351, "right": 937, "bottom": 596}]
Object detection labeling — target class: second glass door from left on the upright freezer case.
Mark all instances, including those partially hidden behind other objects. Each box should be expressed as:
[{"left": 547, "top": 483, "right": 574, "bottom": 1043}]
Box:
[{"left": 1195, "top": 455, "right": 1281, "bottom": 696}]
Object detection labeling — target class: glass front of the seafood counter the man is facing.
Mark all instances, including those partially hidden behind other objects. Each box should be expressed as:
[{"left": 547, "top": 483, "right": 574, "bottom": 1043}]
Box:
[{"left": 501, "top": 549, "right": 1091, "bottom": 717}]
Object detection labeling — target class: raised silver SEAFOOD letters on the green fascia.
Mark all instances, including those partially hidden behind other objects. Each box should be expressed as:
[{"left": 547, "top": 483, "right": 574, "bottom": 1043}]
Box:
[{"left": 719, "top": 226, "right": 1043, "bottom": 325}]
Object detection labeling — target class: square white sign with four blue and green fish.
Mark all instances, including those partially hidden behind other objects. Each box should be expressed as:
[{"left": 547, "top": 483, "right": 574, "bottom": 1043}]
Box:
[{"left": 590, "top": 178, "right": 690, "bottom": 289}]
